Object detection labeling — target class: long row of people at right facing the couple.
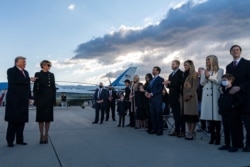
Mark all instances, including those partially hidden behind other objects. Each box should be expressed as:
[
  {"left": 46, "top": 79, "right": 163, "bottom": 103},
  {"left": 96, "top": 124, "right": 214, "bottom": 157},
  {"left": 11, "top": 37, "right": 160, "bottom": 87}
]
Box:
[{"left": 94, "top": 45, "right": 250, "bottom": 152}]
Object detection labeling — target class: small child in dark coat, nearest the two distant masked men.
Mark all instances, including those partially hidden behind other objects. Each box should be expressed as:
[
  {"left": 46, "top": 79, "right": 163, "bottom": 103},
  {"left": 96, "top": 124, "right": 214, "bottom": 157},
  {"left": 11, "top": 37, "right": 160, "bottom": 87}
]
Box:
[{"left": 117, "top": 93, "right": 127, "bottom": 127}]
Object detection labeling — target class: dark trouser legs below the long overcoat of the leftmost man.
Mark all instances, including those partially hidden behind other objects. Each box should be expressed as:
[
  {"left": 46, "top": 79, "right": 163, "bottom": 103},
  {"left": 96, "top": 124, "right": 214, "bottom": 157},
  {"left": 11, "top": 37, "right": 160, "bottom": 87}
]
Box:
[{"left": 6, "top": 122, "right": 25, "bottom": 144}]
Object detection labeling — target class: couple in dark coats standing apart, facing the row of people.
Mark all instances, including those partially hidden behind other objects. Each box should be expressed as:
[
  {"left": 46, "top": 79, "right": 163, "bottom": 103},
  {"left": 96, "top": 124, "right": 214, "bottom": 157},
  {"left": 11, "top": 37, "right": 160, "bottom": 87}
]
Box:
[{"left": 5, "top": 56, "right": 56, "bottom": 147}]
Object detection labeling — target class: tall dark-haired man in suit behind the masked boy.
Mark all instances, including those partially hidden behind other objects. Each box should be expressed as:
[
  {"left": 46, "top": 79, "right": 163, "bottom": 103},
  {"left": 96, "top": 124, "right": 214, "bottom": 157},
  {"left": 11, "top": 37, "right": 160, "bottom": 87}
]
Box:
[{"left": 226, "top": 45, "right": 250, "bottom": 152}]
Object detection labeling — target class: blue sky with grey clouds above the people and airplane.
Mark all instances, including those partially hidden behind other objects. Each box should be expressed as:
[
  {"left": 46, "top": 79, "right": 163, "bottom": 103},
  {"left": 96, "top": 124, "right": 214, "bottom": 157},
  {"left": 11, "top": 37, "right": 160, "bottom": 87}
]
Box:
[{"left": 0, "top": 0, "right": 250, "bottom": 84}]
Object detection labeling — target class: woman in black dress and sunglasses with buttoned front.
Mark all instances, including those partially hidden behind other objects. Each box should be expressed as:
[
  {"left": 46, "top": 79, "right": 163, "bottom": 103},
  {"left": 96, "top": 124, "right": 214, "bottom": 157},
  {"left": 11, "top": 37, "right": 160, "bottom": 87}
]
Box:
[{"left": 33, "top": 60, "right": 56, "bottom": 144}]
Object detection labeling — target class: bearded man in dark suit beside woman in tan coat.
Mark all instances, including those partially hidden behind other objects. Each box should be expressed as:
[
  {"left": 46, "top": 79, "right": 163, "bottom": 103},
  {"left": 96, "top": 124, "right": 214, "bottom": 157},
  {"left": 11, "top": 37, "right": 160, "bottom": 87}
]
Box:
[{"left": 164, "top": 60, "right": 185, "bottom": 137}]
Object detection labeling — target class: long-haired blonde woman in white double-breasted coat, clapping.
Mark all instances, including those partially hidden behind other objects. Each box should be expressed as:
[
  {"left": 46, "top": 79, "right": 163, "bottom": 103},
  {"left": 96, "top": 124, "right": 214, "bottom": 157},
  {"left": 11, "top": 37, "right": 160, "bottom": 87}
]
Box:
[{"left": 200, "top": 55, "right": 223, "bottom": 145}]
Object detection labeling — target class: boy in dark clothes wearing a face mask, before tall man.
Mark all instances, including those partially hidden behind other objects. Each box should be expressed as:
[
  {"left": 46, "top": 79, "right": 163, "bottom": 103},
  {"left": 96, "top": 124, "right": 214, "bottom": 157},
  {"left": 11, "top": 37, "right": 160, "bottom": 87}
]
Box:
[{"left": 218, "top": 74, "right": 244, "bottom": 152}]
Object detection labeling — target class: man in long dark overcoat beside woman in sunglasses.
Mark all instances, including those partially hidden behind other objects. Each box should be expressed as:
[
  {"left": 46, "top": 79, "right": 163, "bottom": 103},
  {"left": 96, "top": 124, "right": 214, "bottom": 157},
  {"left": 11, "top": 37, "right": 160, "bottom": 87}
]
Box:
[{"left": 5, "top": 56, "right": 35, "bottom": 147}]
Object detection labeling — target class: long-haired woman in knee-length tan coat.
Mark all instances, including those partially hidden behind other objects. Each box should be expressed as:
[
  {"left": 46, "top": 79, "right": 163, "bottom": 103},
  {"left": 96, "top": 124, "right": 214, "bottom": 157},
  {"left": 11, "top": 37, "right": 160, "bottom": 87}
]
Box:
[{"left": 181, "top": 60, "right": 199, "bottom": 140}]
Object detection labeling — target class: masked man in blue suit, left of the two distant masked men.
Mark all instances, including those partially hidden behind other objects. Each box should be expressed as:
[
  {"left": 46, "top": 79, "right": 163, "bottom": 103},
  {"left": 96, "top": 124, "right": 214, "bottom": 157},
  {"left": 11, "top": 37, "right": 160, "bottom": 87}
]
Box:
[{"left": 92, "top": 82, "right": 108, "bottom": 124}]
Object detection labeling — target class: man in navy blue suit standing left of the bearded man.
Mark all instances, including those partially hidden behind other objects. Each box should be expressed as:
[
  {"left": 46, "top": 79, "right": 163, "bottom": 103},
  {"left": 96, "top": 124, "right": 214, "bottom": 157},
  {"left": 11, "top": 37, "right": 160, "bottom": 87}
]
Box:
[{"left": 145, "top": 66, "right": 164, "bottom": 136}]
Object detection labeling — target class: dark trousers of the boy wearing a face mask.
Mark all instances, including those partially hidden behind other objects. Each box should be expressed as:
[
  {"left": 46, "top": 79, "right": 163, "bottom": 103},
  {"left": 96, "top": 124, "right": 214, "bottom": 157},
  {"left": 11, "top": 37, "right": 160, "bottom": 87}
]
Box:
[{"left": 222, "top": 114, "right": 243, "bottom": 148}]
